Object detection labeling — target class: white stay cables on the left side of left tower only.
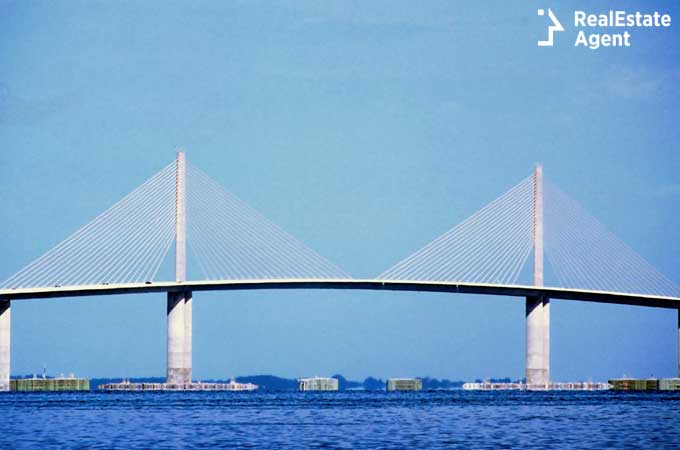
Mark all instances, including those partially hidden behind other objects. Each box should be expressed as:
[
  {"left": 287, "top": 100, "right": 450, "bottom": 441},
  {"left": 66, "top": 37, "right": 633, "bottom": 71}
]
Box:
[{"left": 0, "top": 162, "right": 175, "bottom": 288}]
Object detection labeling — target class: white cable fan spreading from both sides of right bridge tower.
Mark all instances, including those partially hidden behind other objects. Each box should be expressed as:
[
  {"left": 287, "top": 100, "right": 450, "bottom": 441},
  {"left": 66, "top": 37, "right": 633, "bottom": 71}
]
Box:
[{"left": 379, "top": 172, "right": 680, "bottom": 297}]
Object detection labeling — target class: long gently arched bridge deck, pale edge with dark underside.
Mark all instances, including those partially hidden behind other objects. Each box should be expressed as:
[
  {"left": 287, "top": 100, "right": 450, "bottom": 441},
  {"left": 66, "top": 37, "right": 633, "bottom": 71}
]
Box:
[{"left": 0, "top": 279, "right": 680, "bottom": 309}]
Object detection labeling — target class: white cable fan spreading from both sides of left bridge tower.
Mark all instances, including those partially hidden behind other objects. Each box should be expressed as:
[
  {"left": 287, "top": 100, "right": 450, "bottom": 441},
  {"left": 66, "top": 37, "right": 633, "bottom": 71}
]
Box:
[{"left": 0, "top": 162, "right": 350, "bottom": 288}]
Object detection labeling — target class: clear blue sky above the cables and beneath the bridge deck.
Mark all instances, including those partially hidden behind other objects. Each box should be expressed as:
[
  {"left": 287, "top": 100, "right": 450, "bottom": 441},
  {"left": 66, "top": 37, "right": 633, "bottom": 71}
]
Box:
[{"left": 0, "top": 1, "right": 680, "bottom": 380}]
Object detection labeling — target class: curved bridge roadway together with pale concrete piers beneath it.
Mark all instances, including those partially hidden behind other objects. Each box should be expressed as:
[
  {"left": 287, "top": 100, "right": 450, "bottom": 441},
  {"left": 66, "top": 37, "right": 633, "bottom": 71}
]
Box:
[{"left": 0, "top": 278, "right": 680, "bottom": 387}]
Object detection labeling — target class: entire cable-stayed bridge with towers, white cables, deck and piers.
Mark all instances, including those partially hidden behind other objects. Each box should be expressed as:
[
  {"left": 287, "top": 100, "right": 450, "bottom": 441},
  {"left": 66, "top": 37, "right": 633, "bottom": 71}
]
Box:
[{"left": 0, "top": 152, "right": 680, "bottom": 390}]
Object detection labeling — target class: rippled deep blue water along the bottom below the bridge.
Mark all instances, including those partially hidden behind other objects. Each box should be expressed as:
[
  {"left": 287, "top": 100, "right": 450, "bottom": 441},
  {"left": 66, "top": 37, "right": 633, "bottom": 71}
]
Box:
[{"left": 0, "top": 391, "right": 680, "bottom": 449}]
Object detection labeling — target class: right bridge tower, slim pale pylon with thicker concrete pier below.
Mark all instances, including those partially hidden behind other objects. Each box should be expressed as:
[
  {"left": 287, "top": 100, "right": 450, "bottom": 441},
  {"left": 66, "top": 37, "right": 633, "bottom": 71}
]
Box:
[{"left": 526, "top": 165, "right": 550, "bottom": 387}]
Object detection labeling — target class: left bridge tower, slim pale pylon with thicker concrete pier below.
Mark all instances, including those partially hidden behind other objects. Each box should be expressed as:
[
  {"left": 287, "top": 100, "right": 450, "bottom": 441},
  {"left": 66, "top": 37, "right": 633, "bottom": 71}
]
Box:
[{"left": 166, "top": 151, "right": 192, "bottom": 384}]
